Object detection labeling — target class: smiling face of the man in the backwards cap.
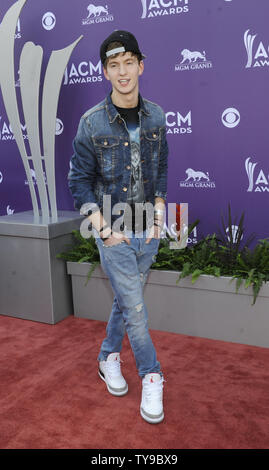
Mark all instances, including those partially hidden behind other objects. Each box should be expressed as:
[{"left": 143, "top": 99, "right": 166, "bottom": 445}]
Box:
[{"left": 104, "top": 52, "right": 144, "bottom": 95}]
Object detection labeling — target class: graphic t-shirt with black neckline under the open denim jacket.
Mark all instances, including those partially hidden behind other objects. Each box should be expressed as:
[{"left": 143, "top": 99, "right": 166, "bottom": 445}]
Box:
[{"left": 115, "top": 105, "right": 146, "bottom": 231}]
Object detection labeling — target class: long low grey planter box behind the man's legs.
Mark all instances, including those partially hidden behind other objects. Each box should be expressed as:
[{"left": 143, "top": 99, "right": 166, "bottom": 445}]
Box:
[{"left": 67, "top": 262, "right": 269, "bottom": 347}]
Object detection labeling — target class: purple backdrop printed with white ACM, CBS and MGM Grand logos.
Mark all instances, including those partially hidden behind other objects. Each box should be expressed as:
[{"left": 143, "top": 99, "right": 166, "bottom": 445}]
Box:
[{"left": 0, "top": 0, "right": 269, "bottom": 243}]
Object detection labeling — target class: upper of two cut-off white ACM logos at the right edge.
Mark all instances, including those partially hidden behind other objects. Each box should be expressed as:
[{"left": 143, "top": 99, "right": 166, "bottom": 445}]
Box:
[{"left": 244, "top": 29, "right": 269, "bottom": 69}]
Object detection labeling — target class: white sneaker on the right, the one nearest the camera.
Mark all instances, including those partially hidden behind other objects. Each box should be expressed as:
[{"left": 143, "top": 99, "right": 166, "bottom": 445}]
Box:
[{"left": 140, "top": 372, "right": 164, "bottom": 423}]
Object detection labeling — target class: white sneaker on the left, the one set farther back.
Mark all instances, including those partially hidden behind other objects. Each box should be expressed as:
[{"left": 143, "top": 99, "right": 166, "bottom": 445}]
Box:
[{"left": 98, "top": 353, "right": 128, "bottom": 396}]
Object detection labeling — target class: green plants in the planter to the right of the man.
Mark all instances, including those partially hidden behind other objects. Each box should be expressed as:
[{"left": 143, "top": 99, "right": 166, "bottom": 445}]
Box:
[{"left": 169, "top": 204, "right": 269, "bottom": 305}]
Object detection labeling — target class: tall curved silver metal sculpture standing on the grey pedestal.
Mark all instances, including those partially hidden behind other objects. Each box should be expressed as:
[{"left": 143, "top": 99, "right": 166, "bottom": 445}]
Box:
[{"left": 0, "top": 0, "right": 83, "bottom": 223}]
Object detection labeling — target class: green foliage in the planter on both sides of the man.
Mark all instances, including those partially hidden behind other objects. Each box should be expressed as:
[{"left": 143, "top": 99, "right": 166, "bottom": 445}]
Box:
[{"left": 57, "top": 205, "right": 269, "bottom": 305}]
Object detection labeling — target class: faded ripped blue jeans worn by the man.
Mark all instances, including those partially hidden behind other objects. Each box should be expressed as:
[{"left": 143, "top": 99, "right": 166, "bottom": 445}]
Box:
[{"left": 95, "top": 230, "right": 162, "bottom": 378}]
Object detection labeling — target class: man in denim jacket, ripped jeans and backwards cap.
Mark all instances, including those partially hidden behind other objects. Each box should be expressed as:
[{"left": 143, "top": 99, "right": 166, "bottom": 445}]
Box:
[{"left": 68, "top": 30, "right": 168, "bottom": 423}]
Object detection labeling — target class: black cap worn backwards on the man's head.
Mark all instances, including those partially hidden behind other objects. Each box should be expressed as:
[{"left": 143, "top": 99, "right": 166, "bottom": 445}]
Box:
[{"left": 100, "top": 30, "right": 146, "bottom": 64}]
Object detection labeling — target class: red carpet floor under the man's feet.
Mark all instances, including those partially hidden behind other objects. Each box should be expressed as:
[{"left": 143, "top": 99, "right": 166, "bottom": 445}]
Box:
[{"left": 0, "top": 316, "right": 269, "bottom": 449}]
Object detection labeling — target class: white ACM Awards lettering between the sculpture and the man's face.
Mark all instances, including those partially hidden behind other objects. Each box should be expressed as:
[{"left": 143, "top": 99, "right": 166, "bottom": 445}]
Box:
[{"left": 63, "top": 60, "right": 103, "bottom": 85}]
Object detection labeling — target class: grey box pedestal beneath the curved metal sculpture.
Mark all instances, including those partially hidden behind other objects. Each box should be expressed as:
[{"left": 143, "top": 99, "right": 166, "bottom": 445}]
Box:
[{"left": 0, "top": 211, "right": 82, "bottom": 324}]
